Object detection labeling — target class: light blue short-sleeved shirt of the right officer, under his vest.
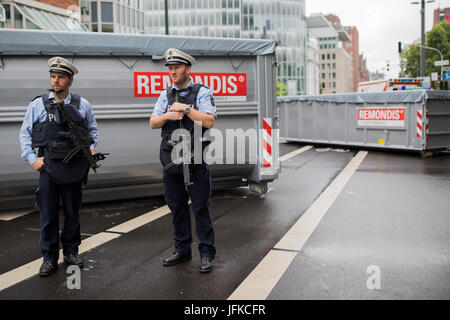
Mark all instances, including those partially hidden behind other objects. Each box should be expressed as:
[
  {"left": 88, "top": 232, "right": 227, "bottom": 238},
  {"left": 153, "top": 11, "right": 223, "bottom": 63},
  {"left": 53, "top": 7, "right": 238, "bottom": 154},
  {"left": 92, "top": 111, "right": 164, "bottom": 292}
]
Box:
[{"left": 152, "top": 78, "right": 217, "bottom": 118}]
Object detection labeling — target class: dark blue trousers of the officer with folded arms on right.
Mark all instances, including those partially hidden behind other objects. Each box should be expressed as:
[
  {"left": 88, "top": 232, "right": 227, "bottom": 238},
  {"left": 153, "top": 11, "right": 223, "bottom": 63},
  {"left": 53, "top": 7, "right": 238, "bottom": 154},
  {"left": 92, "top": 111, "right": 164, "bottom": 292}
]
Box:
[{"left": 164, "top": 164, "right": 216, "bottom": 259}]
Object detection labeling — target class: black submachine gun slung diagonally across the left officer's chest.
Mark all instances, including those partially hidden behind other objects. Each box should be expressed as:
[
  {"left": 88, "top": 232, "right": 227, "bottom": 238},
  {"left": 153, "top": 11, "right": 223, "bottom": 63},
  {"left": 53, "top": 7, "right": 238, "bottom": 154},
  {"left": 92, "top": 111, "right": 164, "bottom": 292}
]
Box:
[{"left": 49, "top": 89, "right": 109, "bottom": 173}]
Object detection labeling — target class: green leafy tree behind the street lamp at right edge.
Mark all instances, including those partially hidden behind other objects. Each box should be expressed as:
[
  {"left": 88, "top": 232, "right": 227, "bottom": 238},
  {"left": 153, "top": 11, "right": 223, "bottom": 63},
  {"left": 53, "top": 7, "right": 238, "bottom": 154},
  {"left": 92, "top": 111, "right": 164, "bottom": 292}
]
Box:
[{"left": 400, "top": 21, "right": 450, "bottom": 78}]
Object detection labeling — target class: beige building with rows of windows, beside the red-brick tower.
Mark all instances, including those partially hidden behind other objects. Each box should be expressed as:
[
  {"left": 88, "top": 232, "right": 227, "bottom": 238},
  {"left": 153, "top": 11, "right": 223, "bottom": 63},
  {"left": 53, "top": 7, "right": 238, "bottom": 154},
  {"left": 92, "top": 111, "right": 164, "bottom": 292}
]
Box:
[{"left": 307, "top": 13, "right": 359, "bottom": 94}]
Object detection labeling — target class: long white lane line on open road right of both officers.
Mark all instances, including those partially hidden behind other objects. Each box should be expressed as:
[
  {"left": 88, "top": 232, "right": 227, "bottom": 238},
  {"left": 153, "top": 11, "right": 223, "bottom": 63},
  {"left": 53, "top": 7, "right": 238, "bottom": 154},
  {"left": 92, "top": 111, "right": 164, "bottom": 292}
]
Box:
[{"left": 228, "top": 151, "right": 368, "bottom": 300}]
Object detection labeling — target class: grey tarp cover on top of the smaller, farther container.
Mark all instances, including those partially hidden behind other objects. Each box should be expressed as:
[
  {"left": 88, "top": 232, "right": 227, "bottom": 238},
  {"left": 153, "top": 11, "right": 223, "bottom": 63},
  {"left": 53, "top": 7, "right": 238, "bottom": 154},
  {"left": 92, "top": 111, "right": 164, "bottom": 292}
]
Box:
[{"left": 278, "top": 90, "right": 450, "bottom": 103}]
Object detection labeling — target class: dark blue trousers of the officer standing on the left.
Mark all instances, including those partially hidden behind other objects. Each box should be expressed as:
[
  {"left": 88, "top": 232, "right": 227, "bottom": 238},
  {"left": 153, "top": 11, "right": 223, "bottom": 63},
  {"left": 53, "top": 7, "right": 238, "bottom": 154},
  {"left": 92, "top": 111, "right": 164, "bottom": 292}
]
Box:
[{"left": 36, "top": 171, "right": 83, "bottom": 261}]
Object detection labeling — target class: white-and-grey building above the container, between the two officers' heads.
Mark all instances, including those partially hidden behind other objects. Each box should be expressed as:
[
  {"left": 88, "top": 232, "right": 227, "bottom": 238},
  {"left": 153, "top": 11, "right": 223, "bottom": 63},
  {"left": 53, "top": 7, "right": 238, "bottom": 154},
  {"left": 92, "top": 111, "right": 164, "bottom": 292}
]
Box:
[{"left": 80, "top": 0, "right": 144, "bottom": 34}]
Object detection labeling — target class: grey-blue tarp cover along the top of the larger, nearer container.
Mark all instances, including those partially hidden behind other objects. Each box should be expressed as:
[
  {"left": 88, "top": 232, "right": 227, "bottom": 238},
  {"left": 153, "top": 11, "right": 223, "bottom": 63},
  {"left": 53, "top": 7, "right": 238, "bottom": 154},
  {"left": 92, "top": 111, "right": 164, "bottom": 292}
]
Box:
[{"left": 0, "top": 30, "right": 277, "bottom": 56}]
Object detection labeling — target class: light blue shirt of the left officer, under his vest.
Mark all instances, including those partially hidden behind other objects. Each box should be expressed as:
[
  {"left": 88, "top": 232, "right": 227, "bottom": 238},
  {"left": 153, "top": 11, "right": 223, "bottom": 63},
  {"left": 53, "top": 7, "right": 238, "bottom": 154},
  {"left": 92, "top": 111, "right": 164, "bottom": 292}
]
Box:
[{"left": 19, "top": 92, "right": 98, "bottom": 165}]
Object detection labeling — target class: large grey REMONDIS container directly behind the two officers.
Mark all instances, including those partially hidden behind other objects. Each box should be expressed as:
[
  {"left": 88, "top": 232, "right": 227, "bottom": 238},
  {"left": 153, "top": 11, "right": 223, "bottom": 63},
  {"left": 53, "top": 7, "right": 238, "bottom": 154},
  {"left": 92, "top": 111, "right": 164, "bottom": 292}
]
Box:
[{"left": 0, "top": 30, "right": 280, "bottom": 210}]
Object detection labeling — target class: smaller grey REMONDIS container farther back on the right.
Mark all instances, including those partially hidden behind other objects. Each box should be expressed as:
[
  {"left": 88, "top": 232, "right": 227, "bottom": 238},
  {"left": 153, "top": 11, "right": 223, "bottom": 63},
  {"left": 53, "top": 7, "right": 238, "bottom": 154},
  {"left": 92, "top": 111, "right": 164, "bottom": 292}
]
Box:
[{"left": 278, "top": 90, "right": 450, "bottom": 154}]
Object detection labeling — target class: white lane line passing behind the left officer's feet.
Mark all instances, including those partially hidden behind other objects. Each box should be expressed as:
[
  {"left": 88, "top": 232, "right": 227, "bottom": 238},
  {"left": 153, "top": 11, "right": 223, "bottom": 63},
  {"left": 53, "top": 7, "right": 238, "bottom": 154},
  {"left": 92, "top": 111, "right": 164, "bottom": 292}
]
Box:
[{"left": 0, "top": 201, "right": 174, "bottom": 291}]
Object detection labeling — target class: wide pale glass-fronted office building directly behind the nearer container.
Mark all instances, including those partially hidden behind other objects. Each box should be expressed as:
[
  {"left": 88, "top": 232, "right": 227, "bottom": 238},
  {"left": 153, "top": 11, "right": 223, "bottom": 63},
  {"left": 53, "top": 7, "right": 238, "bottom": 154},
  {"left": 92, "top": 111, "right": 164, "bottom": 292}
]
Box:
[{"left": 145, "top": 0, "right": 307, "bottom": 95}]
